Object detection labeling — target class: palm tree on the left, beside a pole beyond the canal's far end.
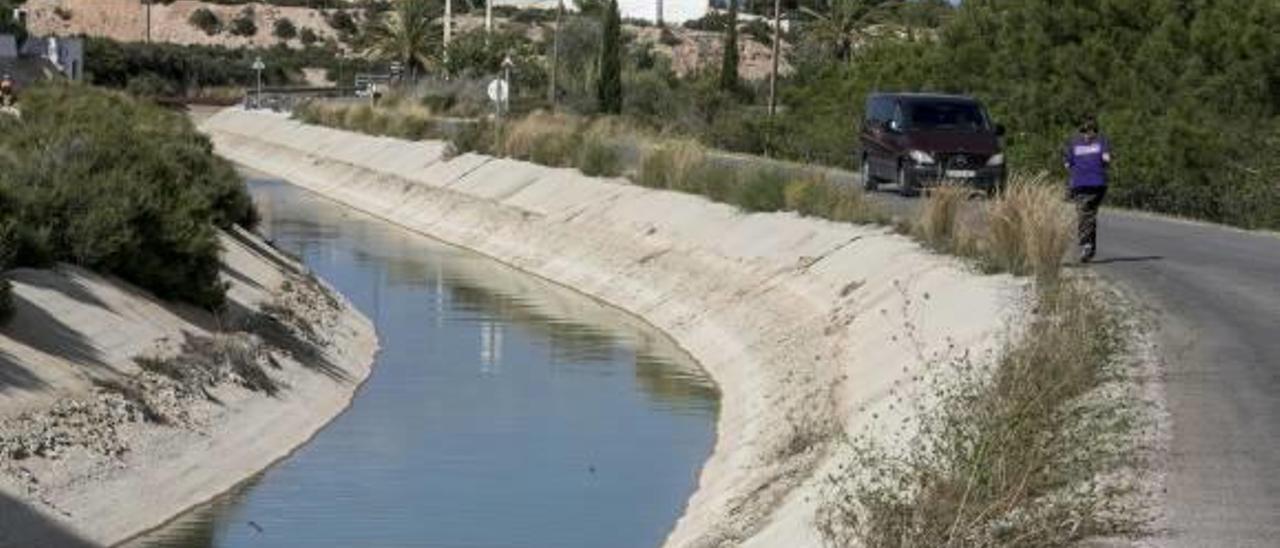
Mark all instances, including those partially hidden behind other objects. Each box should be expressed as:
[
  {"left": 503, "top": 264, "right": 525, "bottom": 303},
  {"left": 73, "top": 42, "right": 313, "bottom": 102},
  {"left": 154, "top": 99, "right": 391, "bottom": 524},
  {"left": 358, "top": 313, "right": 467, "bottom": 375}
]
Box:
[{"left": 369, "top": 0, "right": 439, "bottom": 81}]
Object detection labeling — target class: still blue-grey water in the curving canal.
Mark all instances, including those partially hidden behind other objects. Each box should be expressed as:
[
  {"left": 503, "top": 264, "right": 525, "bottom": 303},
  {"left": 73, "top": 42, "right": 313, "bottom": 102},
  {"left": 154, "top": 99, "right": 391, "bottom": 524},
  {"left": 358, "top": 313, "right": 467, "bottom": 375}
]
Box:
[{"left": 128, "top": 181, "right": 718, "bottom": 548}]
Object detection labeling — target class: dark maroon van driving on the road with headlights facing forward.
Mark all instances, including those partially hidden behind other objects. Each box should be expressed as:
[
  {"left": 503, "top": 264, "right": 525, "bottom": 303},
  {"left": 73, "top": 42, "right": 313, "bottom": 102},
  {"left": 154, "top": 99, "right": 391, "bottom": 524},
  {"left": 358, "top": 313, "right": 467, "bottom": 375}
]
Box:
[{"left": 860, "top": 93, "right": 1005, "bottom": 195}]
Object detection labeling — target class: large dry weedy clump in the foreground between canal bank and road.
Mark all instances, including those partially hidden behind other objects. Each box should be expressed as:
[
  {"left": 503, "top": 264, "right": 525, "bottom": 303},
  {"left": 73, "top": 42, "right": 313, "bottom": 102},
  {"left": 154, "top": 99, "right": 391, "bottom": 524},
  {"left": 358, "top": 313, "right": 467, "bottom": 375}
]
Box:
[{"left": 819, "top": 280, "right": 1142, "bottom": 547}]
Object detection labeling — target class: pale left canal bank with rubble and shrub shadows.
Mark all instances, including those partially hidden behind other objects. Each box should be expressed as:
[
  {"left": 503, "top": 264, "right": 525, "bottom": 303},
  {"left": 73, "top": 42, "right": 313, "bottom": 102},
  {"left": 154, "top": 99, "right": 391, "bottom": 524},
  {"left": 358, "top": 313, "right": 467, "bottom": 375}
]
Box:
[{"left": 0, "top": 225, "right": 378, "bottom": 547}]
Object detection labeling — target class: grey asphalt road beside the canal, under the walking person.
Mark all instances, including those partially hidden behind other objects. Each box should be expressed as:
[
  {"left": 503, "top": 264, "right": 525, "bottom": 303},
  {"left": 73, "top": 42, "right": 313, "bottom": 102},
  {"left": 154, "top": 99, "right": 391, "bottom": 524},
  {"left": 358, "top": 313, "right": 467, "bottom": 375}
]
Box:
[{"left": 874, "top": 185, "right": 1280, "bottom": 548}]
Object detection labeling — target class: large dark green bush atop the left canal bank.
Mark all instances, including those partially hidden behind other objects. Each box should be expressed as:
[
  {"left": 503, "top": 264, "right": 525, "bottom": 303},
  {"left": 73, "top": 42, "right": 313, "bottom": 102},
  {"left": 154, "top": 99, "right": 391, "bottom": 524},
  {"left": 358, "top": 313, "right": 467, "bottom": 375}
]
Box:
[{"left": 0, "top": 83, "right": 256, "bottom": 307}]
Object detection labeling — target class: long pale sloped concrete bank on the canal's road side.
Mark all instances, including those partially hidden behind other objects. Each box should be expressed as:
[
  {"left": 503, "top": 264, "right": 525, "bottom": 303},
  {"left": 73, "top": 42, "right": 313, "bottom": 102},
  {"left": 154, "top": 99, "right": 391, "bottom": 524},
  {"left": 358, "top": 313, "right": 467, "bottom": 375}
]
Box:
[{"left": 202, "top": 109, "right": 1025, "bottom": 547}]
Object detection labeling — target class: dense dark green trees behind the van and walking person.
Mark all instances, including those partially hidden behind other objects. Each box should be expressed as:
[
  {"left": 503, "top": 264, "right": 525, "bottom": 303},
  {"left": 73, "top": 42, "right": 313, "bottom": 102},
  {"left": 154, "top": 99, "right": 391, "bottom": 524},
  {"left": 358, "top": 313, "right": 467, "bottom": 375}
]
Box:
[{"left": 771, "top": 0, "right": 1280, "bottom": 228}]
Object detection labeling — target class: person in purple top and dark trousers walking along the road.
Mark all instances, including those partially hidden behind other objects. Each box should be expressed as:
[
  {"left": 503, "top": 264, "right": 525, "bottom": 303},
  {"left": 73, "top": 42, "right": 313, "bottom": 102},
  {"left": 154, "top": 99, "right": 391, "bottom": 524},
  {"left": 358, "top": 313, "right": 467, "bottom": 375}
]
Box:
[{"left": 1062, "top": 117, "right": 1111, "bottom": 262}]
